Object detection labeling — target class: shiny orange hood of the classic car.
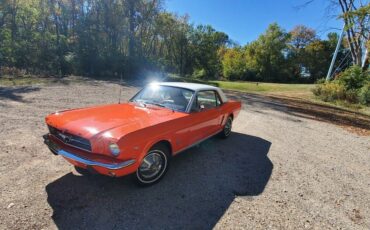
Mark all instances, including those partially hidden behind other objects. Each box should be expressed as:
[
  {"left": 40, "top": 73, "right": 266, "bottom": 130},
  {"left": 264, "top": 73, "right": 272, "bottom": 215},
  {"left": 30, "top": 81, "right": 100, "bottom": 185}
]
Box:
[{"left": 46, "top": 103, "right": 186, "bottom": 139}]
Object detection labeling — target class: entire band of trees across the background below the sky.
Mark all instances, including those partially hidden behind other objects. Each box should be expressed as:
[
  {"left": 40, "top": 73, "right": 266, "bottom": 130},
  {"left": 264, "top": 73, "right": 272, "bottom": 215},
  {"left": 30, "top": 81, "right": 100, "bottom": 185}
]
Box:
[{"left": 0, "top": 0, "right": 368, "bottom": 82}]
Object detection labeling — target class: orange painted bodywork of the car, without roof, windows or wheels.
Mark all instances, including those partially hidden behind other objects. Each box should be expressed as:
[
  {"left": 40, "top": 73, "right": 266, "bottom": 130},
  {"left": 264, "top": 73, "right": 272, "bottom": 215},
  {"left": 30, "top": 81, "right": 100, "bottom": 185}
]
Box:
[{"left": 46, "top": 100, "right": 241, "bottom": 177}]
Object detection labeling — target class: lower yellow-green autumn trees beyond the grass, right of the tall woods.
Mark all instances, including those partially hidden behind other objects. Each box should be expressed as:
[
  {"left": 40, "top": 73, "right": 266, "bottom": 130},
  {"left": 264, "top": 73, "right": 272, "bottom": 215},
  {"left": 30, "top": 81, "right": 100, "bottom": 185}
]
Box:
[{"left": 220, "top": 23, "right": 349, "bottom": 82}]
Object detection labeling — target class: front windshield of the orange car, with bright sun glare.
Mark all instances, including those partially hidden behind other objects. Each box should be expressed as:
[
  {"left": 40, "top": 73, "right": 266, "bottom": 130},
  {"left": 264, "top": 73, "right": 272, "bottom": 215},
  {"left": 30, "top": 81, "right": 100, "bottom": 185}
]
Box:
[{"left": 130, "top": 84, "right": 194, "bottom": 112}]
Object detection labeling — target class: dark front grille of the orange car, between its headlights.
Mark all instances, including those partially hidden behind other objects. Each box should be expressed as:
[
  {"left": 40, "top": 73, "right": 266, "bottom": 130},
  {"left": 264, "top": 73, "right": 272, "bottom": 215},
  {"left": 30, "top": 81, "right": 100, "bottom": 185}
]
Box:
[{"left": 48, "top": 126, "right": 91, "bottom": 152}]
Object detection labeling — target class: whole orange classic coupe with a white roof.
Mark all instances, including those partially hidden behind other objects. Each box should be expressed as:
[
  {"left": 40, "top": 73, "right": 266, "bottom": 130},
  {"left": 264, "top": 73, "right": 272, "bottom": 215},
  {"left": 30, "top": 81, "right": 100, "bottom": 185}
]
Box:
[{"left": 44, "top": 82, "right": 241, "bottom": 185}]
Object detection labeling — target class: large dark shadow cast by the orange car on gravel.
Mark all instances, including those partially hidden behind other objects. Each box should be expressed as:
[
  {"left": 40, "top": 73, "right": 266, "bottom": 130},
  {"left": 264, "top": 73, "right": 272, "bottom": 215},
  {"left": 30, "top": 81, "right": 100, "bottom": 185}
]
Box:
[{"left": 46, "top": 132, "right": 273, "bottom": 229}]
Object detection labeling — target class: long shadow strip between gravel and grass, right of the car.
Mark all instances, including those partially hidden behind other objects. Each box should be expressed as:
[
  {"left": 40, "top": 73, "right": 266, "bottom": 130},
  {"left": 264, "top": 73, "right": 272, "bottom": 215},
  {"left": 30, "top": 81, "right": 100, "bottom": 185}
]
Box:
[{"left": 227, "top": 91, "right": 370, "bottom": 133}]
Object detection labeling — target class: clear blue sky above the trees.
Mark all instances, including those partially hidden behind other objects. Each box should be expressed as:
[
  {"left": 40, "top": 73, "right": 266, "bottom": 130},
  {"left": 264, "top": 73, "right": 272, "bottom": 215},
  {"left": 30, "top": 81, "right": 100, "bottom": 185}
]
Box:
[{"left": 165, "top": 0, "right": 342, "bottom": 45}]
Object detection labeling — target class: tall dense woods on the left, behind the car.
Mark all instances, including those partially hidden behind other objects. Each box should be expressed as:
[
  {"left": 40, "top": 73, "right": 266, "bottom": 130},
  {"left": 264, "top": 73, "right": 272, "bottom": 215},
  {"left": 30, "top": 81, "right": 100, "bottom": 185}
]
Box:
[{"left": 0, "top": 0, "right": 228, "bottom": 77}]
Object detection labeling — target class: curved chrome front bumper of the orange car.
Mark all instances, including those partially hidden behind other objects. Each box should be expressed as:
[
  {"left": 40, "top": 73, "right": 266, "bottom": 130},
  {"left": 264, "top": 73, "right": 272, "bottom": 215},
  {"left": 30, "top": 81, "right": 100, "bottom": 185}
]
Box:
[{"left": 43, "top": 135, "right": 135, "bottom": 170}]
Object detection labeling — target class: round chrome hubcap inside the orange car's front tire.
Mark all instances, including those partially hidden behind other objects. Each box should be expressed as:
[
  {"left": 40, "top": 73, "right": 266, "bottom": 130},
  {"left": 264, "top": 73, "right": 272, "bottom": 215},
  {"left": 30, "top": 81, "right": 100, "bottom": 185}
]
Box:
[{"left": 139, "top": 152, "right": 164, "bottom": 179}]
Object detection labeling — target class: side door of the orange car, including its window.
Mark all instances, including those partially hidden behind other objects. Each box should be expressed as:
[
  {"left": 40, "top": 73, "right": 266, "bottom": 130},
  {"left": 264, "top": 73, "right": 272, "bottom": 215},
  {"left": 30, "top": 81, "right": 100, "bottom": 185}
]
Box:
[{"left": 190, "top": 90, "right": 222, "bottom": 142}]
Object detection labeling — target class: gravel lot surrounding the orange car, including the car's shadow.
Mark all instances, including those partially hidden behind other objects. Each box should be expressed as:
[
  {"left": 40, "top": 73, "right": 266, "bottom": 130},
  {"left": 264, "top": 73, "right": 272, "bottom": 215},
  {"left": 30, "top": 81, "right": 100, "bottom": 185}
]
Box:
[{"left": 0, "top": 78, "right": 370, "bottom": 229}]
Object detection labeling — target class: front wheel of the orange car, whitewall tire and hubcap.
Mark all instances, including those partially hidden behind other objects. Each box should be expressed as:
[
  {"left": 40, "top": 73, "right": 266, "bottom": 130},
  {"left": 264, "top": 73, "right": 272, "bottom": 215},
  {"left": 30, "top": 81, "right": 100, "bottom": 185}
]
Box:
[{"left": 134, "top": 144, "right": 170, "bottom": 186}]
